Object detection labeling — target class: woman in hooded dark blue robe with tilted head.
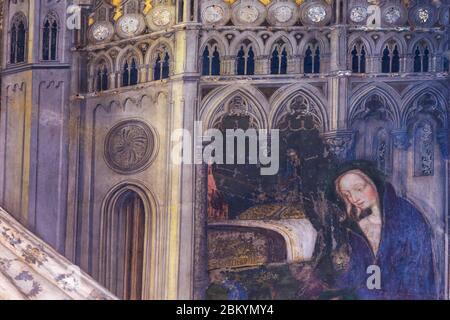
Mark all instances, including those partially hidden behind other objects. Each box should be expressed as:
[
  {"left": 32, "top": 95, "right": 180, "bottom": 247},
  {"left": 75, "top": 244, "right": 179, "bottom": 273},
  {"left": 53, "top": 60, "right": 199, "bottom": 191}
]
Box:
[{"left": 326, "top": 162, "right": 438, "bottom": 300}]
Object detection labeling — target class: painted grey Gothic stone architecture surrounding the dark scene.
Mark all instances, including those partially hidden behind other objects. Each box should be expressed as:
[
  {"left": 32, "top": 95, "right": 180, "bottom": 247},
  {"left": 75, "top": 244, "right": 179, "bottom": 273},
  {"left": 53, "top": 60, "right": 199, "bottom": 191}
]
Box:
[{"left": 0, "top": 0, "right": 450, "bottom": 299}]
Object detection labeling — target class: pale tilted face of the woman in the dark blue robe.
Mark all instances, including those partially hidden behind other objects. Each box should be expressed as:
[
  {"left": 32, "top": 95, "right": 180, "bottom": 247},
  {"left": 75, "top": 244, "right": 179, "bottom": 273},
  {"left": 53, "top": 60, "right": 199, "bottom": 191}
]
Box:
[{"left": 338, "top": 173, "right": 378, "bottom": 211}]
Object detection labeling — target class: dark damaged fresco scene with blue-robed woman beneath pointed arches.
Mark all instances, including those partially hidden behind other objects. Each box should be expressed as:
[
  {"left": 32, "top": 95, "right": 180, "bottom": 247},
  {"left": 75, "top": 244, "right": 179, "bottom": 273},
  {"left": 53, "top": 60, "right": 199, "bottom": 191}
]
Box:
[{"left": 207, "top": 96, "right": 446, "bottom": 300}]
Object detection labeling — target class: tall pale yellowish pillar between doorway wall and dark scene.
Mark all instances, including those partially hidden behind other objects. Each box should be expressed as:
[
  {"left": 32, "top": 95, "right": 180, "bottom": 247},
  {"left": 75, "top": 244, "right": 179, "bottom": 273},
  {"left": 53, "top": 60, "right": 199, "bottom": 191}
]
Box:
[{"left": 169, "top": 24, "right": 199, "bottom": 299}]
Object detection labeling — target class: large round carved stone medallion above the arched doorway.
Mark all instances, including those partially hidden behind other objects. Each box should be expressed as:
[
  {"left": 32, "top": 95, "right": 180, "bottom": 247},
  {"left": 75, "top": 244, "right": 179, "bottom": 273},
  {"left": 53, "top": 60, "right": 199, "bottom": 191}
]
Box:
[{"left": 105, "top": 120, "right": 155, "bottom": 174}]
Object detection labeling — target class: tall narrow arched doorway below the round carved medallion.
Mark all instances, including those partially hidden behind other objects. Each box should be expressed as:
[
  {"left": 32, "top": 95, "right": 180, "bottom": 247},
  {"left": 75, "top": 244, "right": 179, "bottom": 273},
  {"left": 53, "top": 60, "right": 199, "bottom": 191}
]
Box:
[{"left": 102, "top": 188, "right": 150, "bottom": 300}]
